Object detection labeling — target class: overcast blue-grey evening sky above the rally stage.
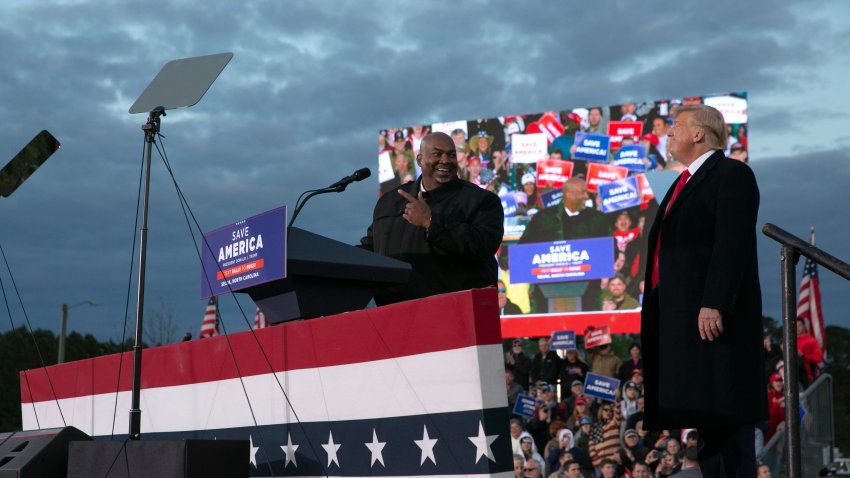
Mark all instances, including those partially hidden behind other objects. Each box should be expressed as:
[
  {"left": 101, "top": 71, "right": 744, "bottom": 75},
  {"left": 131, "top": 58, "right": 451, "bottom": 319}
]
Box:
[{"left": 0, "top": 0, "right": 850, "bottom": 340}]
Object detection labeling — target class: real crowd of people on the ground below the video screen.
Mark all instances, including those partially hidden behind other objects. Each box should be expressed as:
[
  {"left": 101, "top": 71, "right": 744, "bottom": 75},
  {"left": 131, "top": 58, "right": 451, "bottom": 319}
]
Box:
[{"left": 505, "top": 321, "right": 823, "bottom": 478}]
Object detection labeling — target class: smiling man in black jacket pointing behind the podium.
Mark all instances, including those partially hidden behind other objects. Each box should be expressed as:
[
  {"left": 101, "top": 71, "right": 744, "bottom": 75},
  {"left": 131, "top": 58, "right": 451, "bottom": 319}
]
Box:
[{"left": 360, "top": 133, "right": 504, "bottom": 305}]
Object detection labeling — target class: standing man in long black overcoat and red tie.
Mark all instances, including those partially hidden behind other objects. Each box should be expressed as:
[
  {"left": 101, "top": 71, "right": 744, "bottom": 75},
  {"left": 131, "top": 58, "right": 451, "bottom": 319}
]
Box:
[{"left": 641, "top": 105, "right": 767, "bottom": 477}]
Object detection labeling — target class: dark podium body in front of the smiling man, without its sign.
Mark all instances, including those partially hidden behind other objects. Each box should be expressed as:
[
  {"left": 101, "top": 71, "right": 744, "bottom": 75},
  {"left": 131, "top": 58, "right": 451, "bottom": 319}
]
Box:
[{"left": 239, "top": 227, "right": 411, "bottom": 324}]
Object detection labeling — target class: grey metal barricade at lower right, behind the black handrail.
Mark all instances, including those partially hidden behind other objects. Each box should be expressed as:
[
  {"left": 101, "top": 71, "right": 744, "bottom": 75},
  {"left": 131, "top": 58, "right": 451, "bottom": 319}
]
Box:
[{"left": 758, "top": 373, "right": 835, "bottom": 477}]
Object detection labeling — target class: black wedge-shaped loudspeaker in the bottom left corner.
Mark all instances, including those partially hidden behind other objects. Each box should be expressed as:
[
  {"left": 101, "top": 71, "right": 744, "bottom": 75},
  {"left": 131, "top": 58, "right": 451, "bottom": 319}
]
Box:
[{"left": 0, "top": 427, "right": 91, "bottom": 478}]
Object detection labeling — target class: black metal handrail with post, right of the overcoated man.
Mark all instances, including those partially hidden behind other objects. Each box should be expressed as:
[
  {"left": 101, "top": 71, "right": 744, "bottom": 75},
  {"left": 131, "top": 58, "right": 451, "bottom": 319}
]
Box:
[{"left": 762, "top": 224, "right": 850, "bottom": 478}]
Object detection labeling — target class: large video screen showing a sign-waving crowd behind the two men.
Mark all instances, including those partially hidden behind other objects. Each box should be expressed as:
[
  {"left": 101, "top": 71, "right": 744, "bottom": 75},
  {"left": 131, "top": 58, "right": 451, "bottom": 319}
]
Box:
[{"left": 378, "top": 92, "right": 749, "bottom": 315}]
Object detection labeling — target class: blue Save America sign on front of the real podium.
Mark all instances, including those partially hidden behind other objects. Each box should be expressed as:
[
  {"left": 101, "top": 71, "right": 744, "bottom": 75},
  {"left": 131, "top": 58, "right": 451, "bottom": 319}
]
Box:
[{"left": 201, "top": 206, "right": 286, "bottom": 299}]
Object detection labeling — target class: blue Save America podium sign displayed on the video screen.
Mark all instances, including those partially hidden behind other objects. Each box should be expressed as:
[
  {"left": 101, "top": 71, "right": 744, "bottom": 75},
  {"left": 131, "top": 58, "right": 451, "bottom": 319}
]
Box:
[{"left": 508, "top": 237, "right": 614, "bottom": 284}]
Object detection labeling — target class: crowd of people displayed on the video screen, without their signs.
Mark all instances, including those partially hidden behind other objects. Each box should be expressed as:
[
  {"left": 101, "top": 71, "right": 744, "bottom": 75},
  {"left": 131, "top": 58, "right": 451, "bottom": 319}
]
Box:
[{"left": 378, "top": 97, "right": 748, "bottom": 314}]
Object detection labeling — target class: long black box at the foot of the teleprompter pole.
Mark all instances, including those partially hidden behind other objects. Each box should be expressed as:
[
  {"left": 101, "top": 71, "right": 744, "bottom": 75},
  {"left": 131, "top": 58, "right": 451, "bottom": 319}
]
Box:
[{"left": 68, "top": 440, "right": 250, "bottom": 478}]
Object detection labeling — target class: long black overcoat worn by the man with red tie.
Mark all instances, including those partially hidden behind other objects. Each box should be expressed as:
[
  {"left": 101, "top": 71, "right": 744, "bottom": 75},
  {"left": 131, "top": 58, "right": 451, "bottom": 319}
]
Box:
[{"left": 641, "top": 151, "right": 767, "bottom": 429}]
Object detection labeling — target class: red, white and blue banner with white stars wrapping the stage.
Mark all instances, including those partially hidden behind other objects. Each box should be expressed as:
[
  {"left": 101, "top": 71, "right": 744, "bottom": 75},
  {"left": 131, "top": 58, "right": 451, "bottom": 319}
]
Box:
[{"left": 20, "top": 288, "right": 513, "bottom": 478}]
